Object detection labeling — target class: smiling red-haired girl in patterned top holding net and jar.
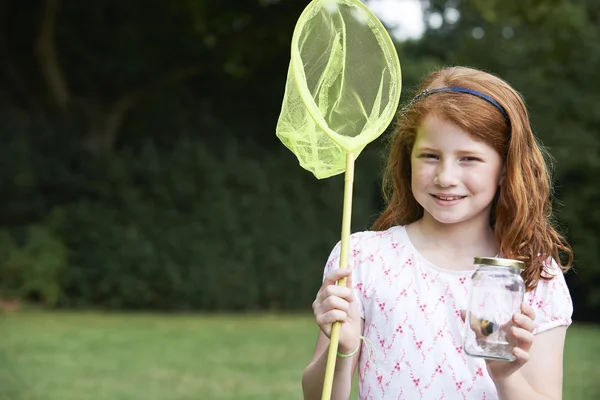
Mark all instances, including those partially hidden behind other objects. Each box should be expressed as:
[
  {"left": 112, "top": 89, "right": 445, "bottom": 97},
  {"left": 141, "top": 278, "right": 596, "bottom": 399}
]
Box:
[{"left": 302, "top": 67, "right": 573, "bottom": 400}]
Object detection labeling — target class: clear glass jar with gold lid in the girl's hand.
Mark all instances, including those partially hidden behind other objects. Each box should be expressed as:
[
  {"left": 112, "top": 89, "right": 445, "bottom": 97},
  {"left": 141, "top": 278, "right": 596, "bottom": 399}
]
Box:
[{"left": 463, "top": 257, "right": 525, "bottom": 361}]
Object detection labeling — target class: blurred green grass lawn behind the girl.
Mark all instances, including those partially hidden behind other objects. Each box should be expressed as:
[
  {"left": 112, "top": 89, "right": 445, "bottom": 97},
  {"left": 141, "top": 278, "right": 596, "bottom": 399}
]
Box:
[{"left": 0, "top": 312, "right": 600, "bottom": 400}]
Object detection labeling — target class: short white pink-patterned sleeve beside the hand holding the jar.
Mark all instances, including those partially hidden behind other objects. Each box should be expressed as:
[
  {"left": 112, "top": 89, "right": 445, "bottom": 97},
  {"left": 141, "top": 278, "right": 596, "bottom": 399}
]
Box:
[{"left": 527, "top": 260, "right": 573, "bottom": 334}]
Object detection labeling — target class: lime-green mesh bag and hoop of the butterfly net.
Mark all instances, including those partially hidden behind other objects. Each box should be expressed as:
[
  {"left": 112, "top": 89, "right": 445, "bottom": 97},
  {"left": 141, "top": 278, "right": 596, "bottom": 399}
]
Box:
[{"left": 276, "top": 0, "right": 401, "bottom": 179}]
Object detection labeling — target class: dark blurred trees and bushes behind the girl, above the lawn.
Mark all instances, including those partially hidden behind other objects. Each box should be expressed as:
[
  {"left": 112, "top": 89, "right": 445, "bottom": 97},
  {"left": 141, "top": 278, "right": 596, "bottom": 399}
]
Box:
[{"left": 0, "top": 0, "right": 600, "bottom": 320}]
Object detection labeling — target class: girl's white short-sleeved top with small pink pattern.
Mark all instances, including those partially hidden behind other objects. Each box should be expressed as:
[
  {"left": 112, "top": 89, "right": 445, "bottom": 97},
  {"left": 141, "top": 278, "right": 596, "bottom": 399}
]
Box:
[{"left": 325, "top": 226, "right": 573, "bottom": 400}]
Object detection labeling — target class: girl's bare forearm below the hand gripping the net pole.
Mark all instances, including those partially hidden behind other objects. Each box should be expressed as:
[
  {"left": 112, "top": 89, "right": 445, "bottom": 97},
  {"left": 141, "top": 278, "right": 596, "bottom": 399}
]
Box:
[{"left": 302, "top": 347, "right": 358, "bottom": 400}]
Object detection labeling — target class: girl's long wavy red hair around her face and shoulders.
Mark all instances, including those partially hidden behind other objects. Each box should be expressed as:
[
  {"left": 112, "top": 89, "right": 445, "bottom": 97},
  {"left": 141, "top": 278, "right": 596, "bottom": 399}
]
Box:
[{"left": 372, "top": 67, "right": 573, "bottom": 290}]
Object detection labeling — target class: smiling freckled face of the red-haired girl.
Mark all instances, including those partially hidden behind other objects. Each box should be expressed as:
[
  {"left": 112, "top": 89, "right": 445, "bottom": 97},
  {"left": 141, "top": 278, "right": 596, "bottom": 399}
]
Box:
[{"left": 411, "top": 115, "right": 503, "bottom": 226}]
